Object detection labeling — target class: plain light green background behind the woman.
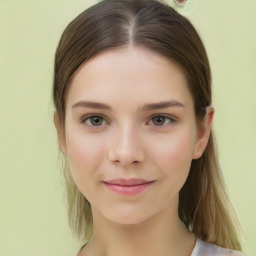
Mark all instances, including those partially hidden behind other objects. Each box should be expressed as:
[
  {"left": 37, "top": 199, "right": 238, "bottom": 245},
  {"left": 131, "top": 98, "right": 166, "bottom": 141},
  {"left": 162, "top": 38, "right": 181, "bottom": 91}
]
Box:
[{"left": 0, "top": 0, "right": 256, "bottom": 256}]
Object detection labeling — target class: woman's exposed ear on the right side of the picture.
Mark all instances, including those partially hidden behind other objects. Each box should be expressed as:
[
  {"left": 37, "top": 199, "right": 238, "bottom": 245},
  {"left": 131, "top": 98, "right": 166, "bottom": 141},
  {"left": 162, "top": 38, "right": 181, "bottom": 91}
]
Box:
[{"left": 192, "top": 107, "right": 214, "bottom": 159}]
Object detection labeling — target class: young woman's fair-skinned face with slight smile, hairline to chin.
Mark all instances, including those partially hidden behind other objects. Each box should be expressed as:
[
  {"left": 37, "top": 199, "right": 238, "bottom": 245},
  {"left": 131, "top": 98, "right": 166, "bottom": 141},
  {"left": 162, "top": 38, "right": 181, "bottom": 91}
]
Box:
[{"left": 57, "top": 47, "right": 211, "bottom": 224}]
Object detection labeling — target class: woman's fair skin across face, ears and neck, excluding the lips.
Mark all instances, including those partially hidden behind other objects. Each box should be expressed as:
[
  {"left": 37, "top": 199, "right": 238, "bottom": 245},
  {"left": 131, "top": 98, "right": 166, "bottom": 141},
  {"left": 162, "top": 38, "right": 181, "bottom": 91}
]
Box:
[{"left": 55, "top": 47, "right": 214, "bottom": 256}]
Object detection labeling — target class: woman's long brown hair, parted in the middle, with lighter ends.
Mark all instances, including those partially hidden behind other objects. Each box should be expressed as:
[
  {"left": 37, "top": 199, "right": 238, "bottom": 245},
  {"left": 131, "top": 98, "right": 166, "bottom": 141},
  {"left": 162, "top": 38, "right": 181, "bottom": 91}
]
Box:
[{"left": 53, "top": 0, "right": 241, "bottom": 250}]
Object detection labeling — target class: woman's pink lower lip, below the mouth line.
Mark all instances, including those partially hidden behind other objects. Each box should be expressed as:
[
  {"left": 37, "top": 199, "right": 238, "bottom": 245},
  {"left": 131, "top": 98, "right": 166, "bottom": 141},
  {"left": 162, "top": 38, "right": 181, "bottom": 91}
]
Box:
[{"left": 104, "top": 181, "right": 153, "bottom": 195}]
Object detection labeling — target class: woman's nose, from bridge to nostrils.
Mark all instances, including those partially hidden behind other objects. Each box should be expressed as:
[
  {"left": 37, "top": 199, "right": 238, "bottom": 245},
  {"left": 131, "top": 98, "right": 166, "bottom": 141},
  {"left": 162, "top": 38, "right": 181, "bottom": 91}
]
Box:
[{"left": 108, "top": 125, "right": 145, "bottom": 166}]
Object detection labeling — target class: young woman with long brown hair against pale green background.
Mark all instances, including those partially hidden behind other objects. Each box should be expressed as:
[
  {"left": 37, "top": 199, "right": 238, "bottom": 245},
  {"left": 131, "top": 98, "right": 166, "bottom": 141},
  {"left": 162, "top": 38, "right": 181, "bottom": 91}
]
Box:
[{"left": 54, "top": 0, "right": 242, "bottom": 256}]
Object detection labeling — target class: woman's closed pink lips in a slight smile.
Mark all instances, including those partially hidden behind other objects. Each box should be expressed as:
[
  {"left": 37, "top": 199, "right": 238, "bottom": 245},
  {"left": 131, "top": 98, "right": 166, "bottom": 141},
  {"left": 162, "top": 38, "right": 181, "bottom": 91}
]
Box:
[{"left": 104, "top": 179, "right": 154, "bottom": 195}]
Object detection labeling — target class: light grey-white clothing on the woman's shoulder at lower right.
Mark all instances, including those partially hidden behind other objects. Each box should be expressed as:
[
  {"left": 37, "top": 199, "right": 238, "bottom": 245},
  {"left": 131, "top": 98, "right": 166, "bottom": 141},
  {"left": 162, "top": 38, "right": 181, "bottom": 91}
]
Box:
[{"left": 191, "top": 238, "right": 244, "bottom": 256}]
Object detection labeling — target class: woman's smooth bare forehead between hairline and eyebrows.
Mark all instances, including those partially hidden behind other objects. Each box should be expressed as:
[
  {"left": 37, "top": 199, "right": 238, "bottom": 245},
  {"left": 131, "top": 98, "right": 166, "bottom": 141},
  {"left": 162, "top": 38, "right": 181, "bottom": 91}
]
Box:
[{"left": 67, "top": 47, "right": 192, "bottom": 108}]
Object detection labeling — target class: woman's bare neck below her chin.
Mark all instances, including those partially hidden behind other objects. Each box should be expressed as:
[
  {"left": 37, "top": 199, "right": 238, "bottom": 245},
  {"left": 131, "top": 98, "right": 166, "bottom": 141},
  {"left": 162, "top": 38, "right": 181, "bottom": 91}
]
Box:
[{"left": 78, "top": 199, "right": 195, "bottom": 256}]
